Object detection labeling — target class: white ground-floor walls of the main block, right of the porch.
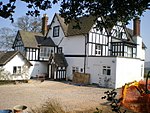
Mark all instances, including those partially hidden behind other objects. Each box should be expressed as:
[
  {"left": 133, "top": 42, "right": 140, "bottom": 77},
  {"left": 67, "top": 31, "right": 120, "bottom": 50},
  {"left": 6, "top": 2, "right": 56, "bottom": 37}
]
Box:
[{"left": 66, "top": 57, "right": 144, "bottom": 88}]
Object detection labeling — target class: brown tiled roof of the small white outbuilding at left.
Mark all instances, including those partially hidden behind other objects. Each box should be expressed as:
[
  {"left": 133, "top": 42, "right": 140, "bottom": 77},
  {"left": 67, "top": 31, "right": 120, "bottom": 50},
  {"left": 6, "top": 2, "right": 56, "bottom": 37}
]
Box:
[{"left": 0, "top": 51, "right": 32, "bottom": 66}]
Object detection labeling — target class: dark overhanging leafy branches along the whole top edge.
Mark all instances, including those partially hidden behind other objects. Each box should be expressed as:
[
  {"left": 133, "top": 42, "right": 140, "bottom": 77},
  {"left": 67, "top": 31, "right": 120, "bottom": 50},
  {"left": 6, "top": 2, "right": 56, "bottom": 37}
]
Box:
[{"left": 0, "top": 0, "right": 150, "bottom": 28}]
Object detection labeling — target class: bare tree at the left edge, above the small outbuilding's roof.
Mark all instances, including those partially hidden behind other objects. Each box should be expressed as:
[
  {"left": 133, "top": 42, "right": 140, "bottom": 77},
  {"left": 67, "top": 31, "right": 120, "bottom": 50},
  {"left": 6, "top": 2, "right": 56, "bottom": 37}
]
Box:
[{"left": 0, "top": 27, "right": 16, "bottom": 50}]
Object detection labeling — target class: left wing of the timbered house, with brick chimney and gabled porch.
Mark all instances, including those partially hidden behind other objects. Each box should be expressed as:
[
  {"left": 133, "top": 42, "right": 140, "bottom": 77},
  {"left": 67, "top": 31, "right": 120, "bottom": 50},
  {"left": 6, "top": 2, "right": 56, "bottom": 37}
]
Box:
[{"left": 13, "top": 15, "right": 67, "bottom": 80}]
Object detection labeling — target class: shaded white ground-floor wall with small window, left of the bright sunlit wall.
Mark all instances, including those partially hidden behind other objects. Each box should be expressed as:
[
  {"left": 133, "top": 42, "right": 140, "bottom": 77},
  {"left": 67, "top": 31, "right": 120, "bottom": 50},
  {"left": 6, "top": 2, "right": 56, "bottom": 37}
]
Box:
[{"left": 86, "top": 57, "right": 116, "bottom": 88}]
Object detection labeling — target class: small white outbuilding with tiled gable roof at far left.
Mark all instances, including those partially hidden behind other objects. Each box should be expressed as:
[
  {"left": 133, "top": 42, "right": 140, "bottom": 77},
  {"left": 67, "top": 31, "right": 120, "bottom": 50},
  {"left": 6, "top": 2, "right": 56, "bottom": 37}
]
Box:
[{"left": 0, "top": 51, "right": 32, "bottom": 80}]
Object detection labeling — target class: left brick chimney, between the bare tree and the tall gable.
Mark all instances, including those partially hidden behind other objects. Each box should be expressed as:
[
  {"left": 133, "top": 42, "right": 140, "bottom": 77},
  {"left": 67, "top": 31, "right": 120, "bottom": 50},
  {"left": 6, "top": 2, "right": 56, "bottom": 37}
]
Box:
[{"left": 42, "top": 14, "right": 48, "bottom": 36}]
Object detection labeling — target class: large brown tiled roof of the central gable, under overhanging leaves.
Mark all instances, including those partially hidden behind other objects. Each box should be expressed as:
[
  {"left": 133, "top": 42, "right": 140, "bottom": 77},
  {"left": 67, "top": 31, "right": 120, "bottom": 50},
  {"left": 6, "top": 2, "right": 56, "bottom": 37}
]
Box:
[{"left": 56, "top": 14, "right": 96, "bottom": 36}]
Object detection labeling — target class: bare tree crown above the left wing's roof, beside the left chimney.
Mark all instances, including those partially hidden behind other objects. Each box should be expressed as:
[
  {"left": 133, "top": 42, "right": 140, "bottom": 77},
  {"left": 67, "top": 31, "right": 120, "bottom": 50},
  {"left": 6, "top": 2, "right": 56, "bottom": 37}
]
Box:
[{"left": 13, "top": 16, "right": 42, "bottom": 32}]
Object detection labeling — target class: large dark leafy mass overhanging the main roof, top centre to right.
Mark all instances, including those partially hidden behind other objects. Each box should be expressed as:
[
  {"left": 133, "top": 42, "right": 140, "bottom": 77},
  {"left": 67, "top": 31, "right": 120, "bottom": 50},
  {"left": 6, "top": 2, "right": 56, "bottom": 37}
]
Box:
[{"left": 60, "top": 0, "right": 150, "bottom": 29}]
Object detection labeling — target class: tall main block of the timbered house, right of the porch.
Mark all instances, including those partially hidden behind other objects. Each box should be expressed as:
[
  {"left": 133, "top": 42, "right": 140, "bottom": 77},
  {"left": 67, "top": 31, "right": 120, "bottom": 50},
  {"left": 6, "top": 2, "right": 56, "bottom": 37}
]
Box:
[{"left": 47, "top": 14, "right": 145, "bottom": 88}]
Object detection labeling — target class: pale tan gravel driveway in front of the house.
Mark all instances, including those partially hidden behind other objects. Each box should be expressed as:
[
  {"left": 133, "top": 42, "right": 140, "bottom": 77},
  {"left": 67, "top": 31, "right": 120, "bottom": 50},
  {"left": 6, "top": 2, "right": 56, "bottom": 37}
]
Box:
[{"left": 0, "top": 80, "right": 112, "bottom": 111}]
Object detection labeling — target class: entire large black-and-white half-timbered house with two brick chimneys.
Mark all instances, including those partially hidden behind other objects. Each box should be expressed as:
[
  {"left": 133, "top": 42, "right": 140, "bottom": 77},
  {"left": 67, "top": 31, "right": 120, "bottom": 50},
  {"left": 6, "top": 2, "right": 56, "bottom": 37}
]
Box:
[{"left": 13, "top": 14, "right": 146, "bottom": 88}]
